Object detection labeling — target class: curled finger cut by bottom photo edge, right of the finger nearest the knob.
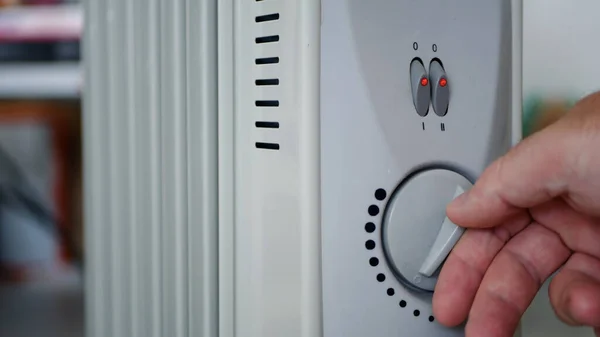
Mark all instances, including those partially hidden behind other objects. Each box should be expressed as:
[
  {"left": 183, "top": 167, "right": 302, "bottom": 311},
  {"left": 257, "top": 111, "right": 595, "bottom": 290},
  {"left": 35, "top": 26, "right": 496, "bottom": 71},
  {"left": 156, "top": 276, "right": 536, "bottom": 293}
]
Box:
[{"left": 465, "top": 223, "right": 571, "bottom": 337}]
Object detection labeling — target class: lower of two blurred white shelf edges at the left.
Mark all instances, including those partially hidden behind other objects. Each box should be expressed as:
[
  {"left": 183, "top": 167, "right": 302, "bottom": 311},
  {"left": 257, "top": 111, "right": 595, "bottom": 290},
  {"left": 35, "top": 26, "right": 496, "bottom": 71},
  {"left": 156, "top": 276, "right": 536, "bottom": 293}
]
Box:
[{"left": 0, "top": 62, "right": 82, "bottom": 99}]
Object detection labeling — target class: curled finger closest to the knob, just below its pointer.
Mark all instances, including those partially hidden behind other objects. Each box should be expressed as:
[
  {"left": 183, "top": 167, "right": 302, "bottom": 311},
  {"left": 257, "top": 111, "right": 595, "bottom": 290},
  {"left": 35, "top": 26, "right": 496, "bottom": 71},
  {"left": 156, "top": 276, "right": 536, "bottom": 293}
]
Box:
[{"left": 433, "top": 211, "right": 530, "bottom": 326}]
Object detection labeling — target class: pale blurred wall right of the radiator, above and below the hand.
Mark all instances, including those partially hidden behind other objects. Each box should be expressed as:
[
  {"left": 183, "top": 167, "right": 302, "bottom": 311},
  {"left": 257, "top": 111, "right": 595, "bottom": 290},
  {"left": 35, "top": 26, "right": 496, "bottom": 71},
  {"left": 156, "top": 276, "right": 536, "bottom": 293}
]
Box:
[{"left": 523, "top": 0, "right": 600, "bottom": 337}]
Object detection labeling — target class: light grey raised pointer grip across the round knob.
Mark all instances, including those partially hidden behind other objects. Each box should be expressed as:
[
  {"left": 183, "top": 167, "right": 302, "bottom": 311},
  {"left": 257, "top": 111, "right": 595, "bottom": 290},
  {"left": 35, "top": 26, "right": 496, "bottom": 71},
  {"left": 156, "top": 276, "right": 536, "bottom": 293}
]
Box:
[{"left": 419, "top": 185, "right": 465, "bottom": 277}]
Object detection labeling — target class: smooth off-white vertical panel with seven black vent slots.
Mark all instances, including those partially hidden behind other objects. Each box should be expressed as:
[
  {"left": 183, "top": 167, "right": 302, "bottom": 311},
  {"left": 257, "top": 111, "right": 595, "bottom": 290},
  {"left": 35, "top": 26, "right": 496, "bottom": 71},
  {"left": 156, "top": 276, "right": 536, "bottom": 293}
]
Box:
[{"left": 219, "top": 0, "right": 322, "bottom": 337}]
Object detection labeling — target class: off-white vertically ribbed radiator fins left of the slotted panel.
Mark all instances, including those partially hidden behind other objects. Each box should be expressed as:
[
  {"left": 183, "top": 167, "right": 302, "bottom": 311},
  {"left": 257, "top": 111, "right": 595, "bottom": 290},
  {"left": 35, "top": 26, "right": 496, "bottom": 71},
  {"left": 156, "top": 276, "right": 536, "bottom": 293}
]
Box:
[{"left": 84, "top": 0, "right": 218, "bottom": 337}]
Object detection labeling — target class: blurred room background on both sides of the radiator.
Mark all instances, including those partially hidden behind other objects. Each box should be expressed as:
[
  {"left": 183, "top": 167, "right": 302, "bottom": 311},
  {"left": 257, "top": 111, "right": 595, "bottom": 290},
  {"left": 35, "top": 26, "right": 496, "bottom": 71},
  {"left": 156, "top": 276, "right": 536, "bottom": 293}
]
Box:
[{"left": 0, "top": 0, "right": 600, "bottom": 337}]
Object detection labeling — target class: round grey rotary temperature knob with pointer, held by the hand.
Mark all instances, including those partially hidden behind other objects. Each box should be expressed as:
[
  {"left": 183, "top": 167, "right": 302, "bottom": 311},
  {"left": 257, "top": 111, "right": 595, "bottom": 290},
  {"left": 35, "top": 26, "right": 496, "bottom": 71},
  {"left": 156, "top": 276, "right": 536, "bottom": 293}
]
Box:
[{"left": 382, "top": 169, "right": 472, "bottom": 292}]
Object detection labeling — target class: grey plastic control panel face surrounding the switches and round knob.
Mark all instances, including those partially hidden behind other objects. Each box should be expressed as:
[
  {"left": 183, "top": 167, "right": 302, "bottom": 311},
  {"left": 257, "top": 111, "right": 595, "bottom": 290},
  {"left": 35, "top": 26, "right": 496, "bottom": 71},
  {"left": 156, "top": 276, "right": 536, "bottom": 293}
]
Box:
[{"left": 321, "top": 0, "right": 521, "bottom": 337}]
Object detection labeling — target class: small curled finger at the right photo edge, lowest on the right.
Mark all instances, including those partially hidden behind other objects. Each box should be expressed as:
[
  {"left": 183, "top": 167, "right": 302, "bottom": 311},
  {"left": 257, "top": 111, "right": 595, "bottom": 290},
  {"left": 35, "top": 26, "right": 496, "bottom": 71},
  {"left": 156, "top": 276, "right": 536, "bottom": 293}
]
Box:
[{"left": 548, "top": 253, "right": 600, "bottom": 327}]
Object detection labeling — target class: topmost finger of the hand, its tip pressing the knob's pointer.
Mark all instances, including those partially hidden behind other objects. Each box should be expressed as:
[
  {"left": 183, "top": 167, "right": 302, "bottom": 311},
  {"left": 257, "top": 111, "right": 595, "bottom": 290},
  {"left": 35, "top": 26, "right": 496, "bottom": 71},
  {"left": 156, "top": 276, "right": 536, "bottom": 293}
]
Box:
[{"left": 448, "top": 92, "right": 600, "bottom": 227}]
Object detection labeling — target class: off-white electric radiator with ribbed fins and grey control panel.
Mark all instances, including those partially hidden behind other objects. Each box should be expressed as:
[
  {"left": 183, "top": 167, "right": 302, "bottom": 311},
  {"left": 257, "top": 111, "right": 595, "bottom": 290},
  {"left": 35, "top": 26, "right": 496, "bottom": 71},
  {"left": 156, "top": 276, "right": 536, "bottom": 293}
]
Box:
[{"left": 84, "top": 0, "right": 522, "bottom": 337}]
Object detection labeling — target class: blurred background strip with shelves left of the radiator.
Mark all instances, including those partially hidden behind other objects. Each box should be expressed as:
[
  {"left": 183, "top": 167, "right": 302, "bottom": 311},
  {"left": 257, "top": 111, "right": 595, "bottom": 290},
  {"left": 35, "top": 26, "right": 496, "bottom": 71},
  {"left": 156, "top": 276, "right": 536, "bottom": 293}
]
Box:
[{"left": 0, "top": 0, "right": 83, "bottom": 337}]
